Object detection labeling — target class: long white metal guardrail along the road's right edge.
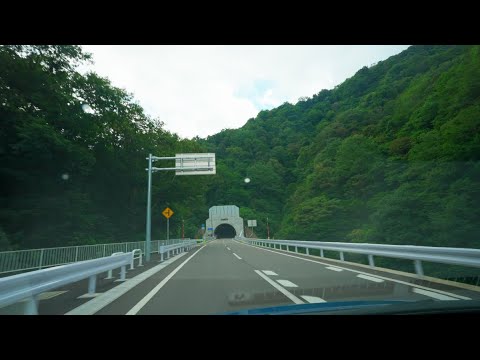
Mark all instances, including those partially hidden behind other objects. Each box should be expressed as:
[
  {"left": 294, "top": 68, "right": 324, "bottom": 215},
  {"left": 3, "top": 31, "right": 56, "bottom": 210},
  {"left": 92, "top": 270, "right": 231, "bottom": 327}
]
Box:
[{"left": 237, "top": 237, "right": 480, "bottom": 276}]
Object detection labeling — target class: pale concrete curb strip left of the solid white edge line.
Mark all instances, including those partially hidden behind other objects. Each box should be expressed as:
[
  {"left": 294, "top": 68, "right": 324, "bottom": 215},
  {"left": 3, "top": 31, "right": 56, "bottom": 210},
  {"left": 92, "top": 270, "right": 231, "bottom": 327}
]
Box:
[{"left": 65, "top": 250, "right": 195, "bottom": 315}]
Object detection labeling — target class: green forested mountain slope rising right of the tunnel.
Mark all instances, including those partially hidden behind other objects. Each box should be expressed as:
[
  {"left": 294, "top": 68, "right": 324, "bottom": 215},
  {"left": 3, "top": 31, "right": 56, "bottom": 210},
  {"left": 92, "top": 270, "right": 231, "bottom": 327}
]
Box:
[{"left": 206, "top": 46, "right": 480, "bottom": 247}]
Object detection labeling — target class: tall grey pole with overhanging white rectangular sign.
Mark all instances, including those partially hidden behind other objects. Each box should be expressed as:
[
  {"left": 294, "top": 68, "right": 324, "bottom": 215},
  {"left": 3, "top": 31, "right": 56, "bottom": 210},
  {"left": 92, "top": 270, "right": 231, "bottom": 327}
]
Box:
[{"left": 145, "top": 153, "right": 216, "bottom": 261}]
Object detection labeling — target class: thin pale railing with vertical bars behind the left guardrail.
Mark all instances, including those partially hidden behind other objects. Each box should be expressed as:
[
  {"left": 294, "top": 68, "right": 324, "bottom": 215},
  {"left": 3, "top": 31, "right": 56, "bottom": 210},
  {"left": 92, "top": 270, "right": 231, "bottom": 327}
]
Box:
[{"left": 0, "top": 239, "right": 189, "bottom": 274}]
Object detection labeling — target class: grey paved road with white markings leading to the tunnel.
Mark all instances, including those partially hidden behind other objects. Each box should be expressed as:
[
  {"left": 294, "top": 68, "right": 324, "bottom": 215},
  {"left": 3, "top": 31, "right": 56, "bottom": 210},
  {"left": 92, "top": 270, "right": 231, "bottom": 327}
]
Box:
[{"left": 4, "top": 239, "right": 480, "bottom": 315}]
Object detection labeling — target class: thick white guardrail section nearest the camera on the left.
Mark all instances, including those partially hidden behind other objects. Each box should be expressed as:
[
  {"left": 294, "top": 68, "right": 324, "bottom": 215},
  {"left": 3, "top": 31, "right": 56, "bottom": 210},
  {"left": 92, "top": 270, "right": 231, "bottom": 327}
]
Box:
[{"left": 0, "top": 252, "right": 134, "bottom": 315}]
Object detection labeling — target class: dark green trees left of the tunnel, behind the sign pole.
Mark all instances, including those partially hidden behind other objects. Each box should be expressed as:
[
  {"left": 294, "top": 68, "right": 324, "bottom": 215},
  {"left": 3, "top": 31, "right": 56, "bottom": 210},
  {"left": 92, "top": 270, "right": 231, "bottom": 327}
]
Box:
[{"left": 0, "top": 46, "right": 208, "bottom": 249}]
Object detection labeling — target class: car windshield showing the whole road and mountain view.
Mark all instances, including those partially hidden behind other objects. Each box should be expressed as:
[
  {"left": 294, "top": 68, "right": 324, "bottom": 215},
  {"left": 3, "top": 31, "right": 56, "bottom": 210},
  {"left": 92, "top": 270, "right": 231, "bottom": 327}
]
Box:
[{"left": 0, "top": 45, "right": 480, "bottom": 315}]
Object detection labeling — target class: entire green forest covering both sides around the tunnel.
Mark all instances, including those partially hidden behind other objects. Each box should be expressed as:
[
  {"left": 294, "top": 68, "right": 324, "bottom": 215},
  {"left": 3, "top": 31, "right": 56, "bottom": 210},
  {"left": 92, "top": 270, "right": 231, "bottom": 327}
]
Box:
[{"left": 0, "top": 46, "right": 480, "bottom": 256}]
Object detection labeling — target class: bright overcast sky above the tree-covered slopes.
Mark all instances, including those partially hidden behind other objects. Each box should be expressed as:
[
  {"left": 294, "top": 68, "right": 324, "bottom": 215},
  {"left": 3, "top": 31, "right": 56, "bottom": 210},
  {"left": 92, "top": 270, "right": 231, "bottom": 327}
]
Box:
[{"left": 81, "top": 45, "right": 408, "bottom": 138}]
